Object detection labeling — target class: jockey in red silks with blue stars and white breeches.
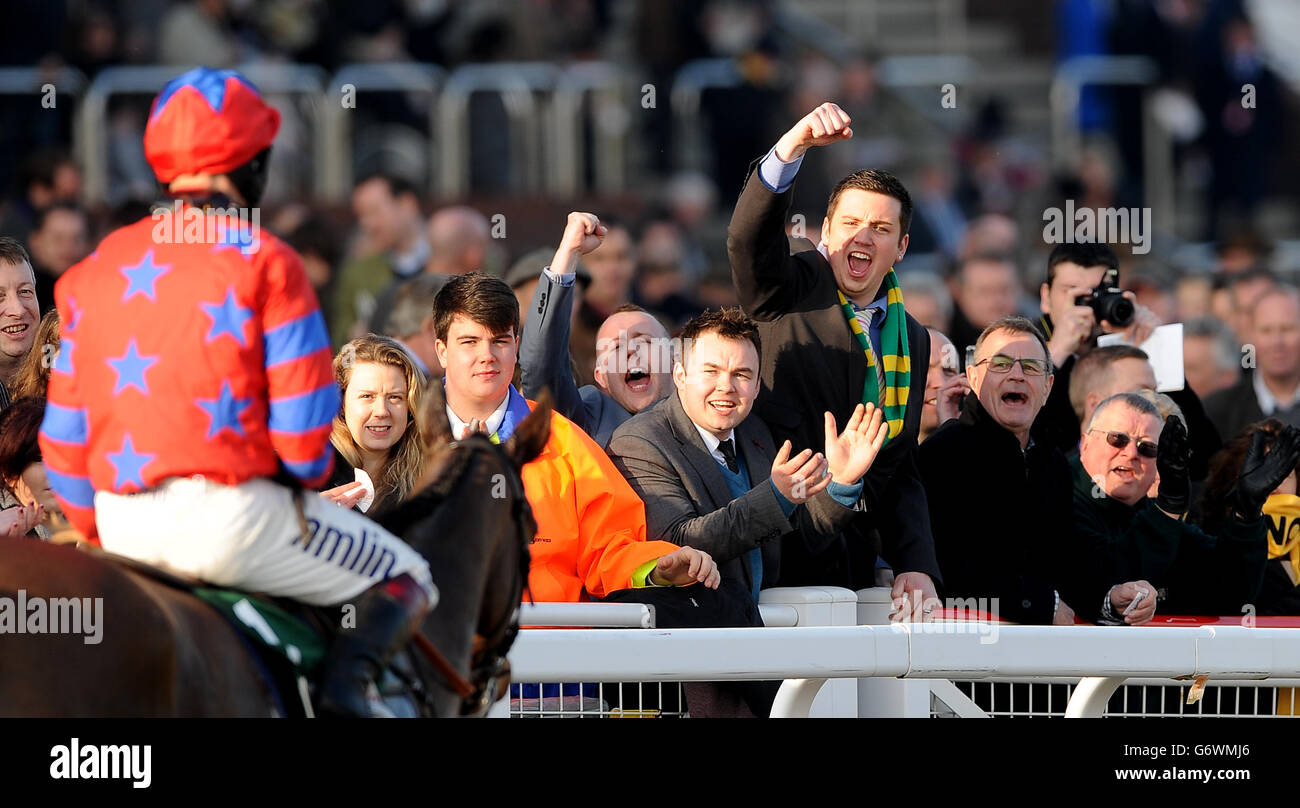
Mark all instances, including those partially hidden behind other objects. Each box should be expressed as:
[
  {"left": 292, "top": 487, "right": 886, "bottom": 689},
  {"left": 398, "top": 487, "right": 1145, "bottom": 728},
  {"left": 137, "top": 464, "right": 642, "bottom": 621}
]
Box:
[{"left": 40, "top": 68, "right": 437, "bottom": 716}]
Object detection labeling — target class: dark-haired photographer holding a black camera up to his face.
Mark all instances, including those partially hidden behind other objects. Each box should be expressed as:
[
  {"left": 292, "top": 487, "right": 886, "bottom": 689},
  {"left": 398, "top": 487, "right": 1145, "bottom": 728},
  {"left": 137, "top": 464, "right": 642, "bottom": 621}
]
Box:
[{"left": 1032, "top": 243, "right": 1223, "bottom": 482}]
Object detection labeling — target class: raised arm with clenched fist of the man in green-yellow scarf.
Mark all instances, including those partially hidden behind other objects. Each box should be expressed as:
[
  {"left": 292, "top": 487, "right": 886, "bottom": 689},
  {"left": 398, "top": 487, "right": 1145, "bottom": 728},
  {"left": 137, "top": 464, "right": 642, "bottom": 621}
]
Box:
[{"left": 727, "top": 103, "right": 853, "bottom": 320}]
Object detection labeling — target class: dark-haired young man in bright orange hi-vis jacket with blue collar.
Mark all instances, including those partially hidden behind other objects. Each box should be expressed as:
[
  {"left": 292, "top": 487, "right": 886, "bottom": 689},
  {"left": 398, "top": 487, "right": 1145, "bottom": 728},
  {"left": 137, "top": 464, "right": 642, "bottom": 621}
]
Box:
[{"left": 434, "top": 273, "right": 720, "bottom": 603}]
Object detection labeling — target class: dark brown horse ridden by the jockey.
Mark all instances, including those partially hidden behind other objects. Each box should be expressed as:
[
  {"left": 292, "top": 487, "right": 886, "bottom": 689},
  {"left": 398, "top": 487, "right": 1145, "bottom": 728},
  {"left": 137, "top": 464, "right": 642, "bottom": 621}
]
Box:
[{"left": 0, "top": 383, "right": 550, "bottom": 716}]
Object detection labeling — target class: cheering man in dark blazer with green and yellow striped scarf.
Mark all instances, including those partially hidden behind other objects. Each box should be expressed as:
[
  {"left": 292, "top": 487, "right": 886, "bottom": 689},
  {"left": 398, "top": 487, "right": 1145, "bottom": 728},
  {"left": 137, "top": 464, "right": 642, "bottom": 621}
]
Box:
[{"left": 727, "top": 103, "right": 939, "bottom": 618}]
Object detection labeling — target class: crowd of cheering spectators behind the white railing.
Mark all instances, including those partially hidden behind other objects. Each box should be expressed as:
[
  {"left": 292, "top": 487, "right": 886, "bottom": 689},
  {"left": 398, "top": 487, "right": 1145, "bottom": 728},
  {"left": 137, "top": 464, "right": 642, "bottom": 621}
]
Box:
[{"left": 0, "top": 3, "right": 1300, "bottom": 714}]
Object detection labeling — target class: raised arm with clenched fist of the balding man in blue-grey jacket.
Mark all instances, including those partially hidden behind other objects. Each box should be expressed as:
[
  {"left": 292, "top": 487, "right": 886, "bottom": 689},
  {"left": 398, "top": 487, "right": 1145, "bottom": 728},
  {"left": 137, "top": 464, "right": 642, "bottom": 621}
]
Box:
[{"left": 519, "top": 212, "right": 606, "bottom": 434}]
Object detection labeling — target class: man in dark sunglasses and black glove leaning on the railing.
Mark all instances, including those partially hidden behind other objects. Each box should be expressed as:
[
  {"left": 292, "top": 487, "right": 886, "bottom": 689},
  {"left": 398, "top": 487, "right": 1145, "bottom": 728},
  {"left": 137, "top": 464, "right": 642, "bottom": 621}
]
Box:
[{"left": 1071, "top": 392, "right": 1300, "bottom": 621}]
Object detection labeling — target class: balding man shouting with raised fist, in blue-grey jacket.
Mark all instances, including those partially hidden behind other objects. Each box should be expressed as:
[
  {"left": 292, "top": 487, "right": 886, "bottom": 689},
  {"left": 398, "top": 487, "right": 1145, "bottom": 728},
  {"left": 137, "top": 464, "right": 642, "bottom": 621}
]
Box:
[{"left": 519, "top": 212, "right": 672, "bottom": 447}]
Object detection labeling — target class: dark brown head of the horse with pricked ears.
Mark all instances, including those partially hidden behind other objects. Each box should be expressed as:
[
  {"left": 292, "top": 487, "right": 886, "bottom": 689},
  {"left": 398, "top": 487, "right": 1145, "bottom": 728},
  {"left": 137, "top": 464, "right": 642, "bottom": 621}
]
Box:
[{"left": 378, "top": 382, "right": 551, "bottom": 716}]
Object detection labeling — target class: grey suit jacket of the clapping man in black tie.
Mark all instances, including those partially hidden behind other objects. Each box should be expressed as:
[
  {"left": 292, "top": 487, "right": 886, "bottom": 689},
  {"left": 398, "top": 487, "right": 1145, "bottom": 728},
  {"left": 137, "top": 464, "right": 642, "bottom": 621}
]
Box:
[{"left": 608, "top": 391, "right": 853, "bottom": 588}]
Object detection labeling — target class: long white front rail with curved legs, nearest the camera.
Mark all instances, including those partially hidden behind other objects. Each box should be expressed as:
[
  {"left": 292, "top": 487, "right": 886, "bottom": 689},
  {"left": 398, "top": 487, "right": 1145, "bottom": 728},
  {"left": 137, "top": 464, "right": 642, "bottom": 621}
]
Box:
[{"left": 511, "top": 624, "right": 1300, "bottom": 716}]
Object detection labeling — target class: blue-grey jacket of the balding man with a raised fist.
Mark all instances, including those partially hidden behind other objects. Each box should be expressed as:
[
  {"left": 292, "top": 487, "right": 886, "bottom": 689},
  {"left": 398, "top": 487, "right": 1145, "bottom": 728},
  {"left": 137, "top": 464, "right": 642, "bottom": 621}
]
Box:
[{"left": 519, "top": 273, "right": 632, "bottom": 448}]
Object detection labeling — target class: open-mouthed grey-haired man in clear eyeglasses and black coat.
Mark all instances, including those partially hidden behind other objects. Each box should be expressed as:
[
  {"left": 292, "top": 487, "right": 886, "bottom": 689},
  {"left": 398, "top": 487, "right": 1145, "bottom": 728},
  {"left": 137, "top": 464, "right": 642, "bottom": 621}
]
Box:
[{"left": 920, "top": 317, "right": 1154, "bottom": 625}]
